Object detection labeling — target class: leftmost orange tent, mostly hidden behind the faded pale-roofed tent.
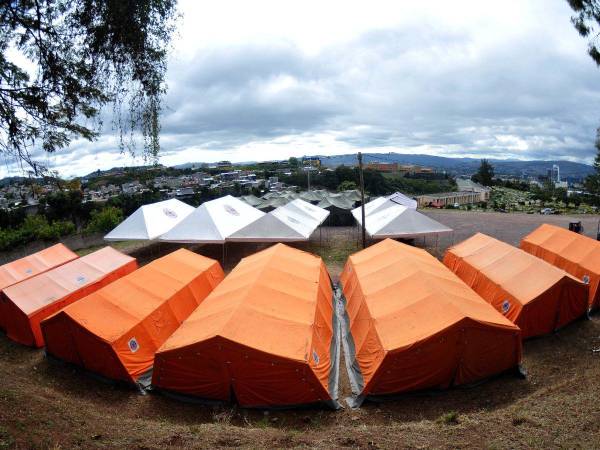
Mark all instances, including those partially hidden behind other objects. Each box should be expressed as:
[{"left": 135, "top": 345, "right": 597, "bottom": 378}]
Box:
[{"left": 0, "top": 244, "right": 78, "bottom": 330}]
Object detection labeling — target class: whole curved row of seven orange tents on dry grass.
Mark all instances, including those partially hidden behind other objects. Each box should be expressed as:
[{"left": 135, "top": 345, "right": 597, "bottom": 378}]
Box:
[{"left": 0, "top": 225, "right": 600, "bottom": 407}]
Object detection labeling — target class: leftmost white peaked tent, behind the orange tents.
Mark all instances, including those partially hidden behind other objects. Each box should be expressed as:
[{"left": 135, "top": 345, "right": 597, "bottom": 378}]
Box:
[{"left": 104, "top": 199, "right": 194, "bottom": 241}]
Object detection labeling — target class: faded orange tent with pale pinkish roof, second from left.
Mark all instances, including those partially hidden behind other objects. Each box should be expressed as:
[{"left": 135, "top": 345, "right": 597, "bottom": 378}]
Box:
[{"left": 0, "top": 247, "right": 137, "bottom": 347}]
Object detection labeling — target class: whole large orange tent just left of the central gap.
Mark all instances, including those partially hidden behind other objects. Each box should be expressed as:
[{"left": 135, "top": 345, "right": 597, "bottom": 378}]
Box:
[{"left": 152, "top": 244, "right": 337, "bottom": 407}]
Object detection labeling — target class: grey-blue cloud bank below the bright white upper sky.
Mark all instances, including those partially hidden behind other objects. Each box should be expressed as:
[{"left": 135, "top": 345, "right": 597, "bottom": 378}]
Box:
[{"left": 4, "top": 5, "right": 600, "bottom": 178}]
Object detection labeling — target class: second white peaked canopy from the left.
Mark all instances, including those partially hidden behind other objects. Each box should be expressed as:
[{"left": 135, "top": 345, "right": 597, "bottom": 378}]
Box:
[{"left": 160, "top": 195, "right": 265, "bottom": 244}]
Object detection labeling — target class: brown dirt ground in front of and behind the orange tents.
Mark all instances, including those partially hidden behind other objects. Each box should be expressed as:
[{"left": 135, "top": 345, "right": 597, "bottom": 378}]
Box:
[{"left": 0, "top": 211, "right": 600, "bottom": 449}]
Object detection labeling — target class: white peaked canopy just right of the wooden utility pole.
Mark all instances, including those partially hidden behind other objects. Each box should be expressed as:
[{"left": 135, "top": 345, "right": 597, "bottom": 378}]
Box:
[{"left": 353, "top": 205, "right": 452, "bottom": 239}]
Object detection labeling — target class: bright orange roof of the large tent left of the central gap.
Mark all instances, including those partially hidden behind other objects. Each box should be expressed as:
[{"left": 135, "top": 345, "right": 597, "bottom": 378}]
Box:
[{"left": 160, "top": 244, "right": 331, "bottom": 361}]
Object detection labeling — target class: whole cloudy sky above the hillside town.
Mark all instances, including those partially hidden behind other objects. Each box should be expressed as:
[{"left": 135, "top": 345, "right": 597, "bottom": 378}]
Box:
[{"left": 0, "top": 0, "right": 600, "bottom": 176}]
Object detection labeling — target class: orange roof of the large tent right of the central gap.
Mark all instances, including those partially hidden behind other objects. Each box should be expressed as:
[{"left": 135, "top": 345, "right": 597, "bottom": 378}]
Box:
[{"left": 345, "top": 239, "right": 518, "bottom": 350}]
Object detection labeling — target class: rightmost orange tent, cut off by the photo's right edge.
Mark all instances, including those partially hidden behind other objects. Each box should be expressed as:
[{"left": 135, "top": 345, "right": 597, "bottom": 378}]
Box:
[{"left": 521, "top": 224, "right": 600, "bottom": 309}]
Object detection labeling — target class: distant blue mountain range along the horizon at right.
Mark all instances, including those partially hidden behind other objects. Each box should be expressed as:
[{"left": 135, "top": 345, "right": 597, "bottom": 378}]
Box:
[{"left": 318, "top": 153, "right": 594, "bottom": 179}]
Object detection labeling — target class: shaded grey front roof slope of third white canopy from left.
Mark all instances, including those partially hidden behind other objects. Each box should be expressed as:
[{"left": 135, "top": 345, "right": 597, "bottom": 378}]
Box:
[{"left": 227, "top": 211, "right": 310, "bottom": 242}]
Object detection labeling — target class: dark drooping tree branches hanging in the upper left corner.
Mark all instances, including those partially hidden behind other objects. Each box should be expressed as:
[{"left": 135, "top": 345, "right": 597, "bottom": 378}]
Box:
[{"left": 0, "top": 0, "right": 176, "bottom": 174}]
